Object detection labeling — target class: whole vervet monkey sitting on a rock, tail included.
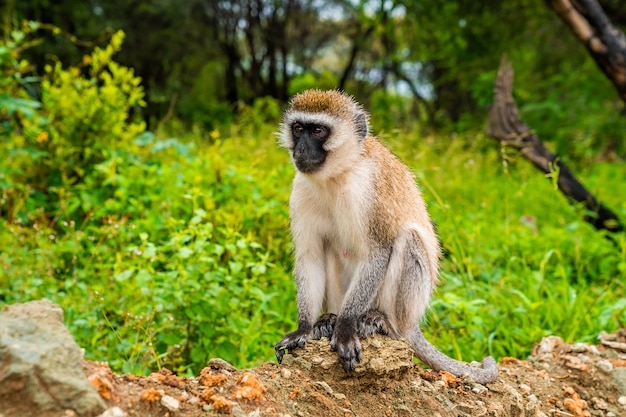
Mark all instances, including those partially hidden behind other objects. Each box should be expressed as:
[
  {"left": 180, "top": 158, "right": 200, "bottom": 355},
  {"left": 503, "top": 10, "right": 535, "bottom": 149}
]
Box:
[{"left": 275, "top": 90, "right": 498, "bottom": 383}]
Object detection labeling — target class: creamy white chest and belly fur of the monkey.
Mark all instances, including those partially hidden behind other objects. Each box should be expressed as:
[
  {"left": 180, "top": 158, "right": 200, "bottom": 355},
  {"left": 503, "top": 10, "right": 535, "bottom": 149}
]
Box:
[{"left": 290, "top": 163, "right": 372, "bottom": 313}]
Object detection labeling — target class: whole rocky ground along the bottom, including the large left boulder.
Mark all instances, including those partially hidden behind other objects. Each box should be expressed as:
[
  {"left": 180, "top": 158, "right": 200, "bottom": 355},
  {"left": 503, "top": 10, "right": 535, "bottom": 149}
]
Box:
[{"left": 0, "top": 300, "right": 626, "bottom": 417}]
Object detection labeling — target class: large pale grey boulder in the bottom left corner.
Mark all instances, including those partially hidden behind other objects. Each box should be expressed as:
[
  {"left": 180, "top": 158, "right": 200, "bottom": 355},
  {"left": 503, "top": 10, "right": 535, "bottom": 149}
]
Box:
[{"left": 0, "top": 299, "right": 107, "bottom": 417}]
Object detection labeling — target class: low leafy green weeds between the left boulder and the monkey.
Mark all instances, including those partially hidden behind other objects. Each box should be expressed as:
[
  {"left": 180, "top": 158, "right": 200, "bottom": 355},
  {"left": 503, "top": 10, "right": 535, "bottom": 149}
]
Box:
[{"left": 0, "top": 131, "right": 296, "bottom": 373}]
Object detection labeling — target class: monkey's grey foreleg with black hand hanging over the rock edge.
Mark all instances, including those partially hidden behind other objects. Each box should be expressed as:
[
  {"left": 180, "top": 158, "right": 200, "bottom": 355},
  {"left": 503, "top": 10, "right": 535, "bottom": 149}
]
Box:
[{"left": 330, "top": 249, "right": 391, "bottom": 372}]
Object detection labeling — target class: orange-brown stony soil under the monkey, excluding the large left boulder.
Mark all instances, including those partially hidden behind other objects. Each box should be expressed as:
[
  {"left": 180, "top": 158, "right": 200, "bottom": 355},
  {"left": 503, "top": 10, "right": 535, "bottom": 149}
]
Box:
[{"left": 83, "top": 329, "right": 626, "bottom": 417}]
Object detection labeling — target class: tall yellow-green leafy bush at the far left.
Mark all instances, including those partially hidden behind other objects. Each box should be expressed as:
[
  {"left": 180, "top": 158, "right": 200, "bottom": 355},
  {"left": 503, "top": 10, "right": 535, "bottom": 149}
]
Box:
[{"left": 0, "top": 27, "right": 145, "bottom": 222}]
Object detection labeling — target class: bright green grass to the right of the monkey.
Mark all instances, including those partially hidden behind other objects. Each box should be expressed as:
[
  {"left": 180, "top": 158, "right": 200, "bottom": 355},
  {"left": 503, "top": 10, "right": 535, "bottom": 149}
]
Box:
[{"left": 390, "top": 136, "right": 626, "bottom": 360}]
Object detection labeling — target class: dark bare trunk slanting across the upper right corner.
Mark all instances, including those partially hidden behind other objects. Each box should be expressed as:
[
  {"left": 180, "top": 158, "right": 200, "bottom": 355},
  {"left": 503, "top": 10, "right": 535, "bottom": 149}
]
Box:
[{"left": 546, "top": 0, "right": 626, "bottom": 103}]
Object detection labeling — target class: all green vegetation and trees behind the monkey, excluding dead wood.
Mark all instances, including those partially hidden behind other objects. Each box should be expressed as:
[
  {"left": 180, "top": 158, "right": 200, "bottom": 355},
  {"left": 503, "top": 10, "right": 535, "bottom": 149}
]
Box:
[{"left": 0, "top": 0, "right": 626, "bottom": 373}]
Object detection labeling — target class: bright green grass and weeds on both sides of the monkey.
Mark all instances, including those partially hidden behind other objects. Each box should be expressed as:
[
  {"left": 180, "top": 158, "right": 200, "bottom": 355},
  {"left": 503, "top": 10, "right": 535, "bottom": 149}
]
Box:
[{"left": 0, "top": 126, "right": 626, "bottom": 373}]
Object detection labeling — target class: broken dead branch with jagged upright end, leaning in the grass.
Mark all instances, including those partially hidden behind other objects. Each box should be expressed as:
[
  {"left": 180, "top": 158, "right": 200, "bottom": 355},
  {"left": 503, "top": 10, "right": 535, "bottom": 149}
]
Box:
[{"left": 487, "top": 57, "right": 624, "bottom": 232}]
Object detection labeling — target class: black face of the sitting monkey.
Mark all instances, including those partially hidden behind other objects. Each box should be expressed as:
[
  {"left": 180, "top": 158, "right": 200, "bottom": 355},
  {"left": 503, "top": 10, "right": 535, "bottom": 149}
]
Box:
[{"left": 291, "top": 122, "right": 330, "bottom": 173}]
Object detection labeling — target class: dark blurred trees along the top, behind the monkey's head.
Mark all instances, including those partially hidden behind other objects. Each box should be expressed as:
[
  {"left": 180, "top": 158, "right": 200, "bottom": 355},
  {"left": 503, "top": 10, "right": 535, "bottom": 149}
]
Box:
[{"left": 2, "top": 0, "right": 626, "bottom": 156}]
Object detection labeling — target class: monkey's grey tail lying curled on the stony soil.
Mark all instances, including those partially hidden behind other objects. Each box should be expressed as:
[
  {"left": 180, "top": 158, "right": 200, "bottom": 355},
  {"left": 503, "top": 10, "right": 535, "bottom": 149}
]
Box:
[{"left": 407, "top": 326, "right": 499, "bottom": 384}]
